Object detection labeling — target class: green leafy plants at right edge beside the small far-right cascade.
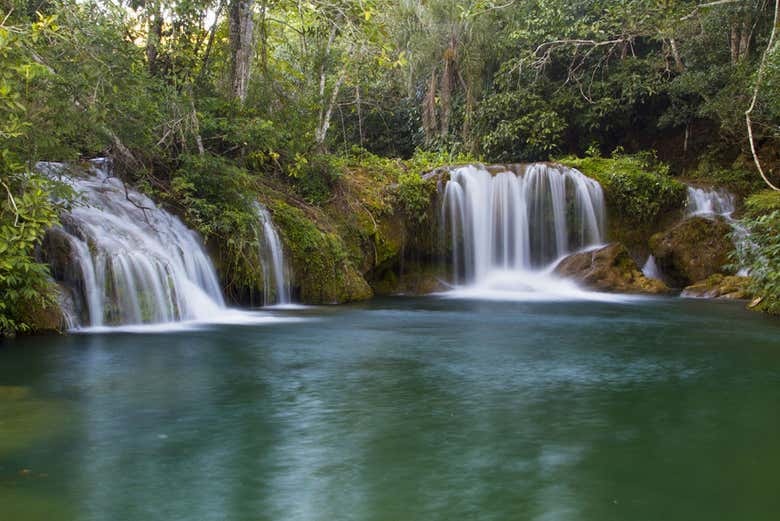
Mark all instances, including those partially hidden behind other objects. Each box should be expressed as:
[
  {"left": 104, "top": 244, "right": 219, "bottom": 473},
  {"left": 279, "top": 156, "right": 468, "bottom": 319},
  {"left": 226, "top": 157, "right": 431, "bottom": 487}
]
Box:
[{"left": 736, "top": 210, "right": 780, "bottom": 314}]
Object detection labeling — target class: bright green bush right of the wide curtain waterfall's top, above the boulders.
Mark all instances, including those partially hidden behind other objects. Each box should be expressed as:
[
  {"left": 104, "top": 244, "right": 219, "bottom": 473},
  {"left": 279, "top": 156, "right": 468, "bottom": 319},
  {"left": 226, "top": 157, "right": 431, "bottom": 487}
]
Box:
[{"left": 560, "top": 149, "right": 686, "bottom": 225}]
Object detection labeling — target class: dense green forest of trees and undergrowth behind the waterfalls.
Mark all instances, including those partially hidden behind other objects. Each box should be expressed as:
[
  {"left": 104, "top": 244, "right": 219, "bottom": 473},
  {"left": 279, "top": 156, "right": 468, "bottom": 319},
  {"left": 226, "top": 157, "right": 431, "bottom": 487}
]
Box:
[{"left": 0, "top": 0, "right": 780, "bottom": 333}]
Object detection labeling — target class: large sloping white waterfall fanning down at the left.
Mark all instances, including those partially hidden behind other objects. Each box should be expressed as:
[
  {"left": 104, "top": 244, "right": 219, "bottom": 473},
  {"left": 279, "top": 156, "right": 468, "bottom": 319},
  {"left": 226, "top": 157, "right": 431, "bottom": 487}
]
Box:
[{"left": 38, "top": 161, "right": 225, "bottom": 327}]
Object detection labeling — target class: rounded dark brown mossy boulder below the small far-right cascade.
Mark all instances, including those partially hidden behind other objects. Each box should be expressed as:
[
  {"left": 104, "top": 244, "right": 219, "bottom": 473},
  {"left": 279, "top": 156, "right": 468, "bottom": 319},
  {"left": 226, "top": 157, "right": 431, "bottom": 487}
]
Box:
[{"left": 650, "top": 217, "right": 734, "bottom": 287}]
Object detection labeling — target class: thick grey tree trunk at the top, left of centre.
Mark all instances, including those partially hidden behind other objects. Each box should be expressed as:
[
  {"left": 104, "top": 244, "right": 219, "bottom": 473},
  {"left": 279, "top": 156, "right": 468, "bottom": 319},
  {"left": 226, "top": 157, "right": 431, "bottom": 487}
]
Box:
[{"left": 229, "top": 0, "right": 254, "bottom": 103}]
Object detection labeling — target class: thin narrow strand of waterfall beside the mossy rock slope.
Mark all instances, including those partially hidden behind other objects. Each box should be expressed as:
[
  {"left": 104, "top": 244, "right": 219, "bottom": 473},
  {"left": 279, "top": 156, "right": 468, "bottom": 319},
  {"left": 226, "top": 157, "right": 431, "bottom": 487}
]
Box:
[{"left": 255, "top": 203, "right": 290, "bottom": 305}]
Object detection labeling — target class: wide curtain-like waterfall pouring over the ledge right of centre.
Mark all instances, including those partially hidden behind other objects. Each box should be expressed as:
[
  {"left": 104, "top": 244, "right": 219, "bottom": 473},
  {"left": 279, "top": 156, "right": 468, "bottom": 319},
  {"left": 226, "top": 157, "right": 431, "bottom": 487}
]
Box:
[{"left": 442, "top": 163, "right": 605, "bottom": 283}]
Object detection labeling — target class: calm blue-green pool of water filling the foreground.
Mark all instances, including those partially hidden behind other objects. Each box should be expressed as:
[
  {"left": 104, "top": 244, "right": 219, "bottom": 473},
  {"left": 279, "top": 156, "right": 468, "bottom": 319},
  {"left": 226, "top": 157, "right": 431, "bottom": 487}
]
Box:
[{"left": 0, "top": 298, "right": 780, "bottom": 521}]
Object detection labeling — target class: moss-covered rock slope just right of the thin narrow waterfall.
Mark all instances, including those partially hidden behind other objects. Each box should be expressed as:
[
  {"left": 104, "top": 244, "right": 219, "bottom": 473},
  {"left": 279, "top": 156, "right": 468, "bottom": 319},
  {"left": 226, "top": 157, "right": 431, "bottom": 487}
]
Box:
[{"left": 268, "top": 200, "right": 372, "bottom": 304}]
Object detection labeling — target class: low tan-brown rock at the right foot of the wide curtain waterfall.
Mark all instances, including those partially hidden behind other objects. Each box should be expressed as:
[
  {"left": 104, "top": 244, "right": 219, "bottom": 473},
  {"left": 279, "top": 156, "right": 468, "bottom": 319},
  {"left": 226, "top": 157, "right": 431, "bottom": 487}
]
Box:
[{"left": 555, "top": 243, "right": 671, "bottom": 295}]
